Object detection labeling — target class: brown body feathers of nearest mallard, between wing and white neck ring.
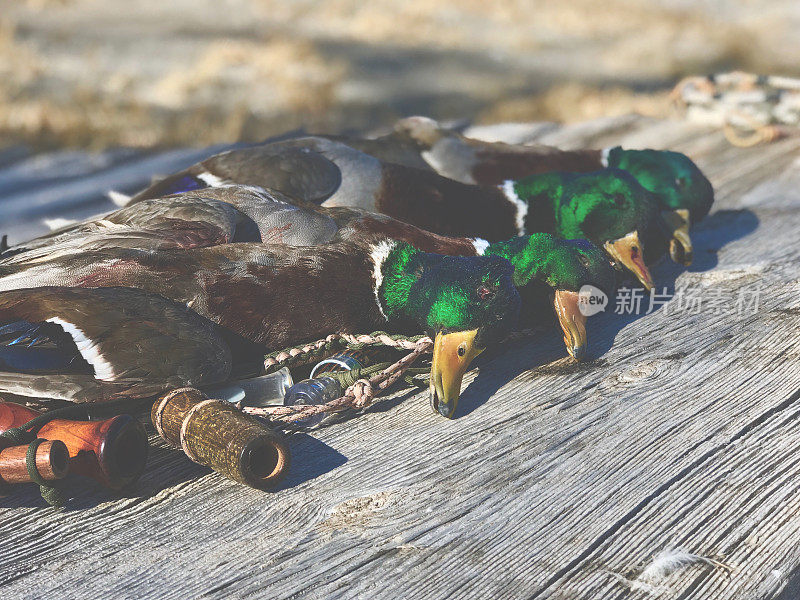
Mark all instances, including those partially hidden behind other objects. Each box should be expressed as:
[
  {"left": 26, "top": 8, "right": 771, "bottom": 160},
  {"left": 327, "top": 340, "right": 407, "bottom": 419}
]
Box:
[{"left": 0, "top": 243, "right": 385, "bottom": 349}]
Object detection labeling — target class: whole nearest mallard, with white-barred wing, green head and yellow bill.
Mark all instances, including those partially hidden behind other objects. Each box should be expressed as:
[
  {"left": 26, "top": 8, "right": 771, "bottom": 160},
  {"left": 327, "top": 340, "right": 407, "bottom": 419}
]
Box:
[{"left": 0, "top": 241, "right": 520, "bottom": 418}]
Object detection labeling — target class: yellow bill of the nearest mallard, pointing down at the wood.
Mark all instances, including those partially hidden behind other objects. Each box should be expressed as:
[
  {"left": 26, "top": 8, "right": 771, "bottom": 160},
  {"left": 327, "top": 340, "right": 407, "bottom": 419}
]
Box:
[{"left": 430, "top": 329, "right": 483, "bottom": 419}]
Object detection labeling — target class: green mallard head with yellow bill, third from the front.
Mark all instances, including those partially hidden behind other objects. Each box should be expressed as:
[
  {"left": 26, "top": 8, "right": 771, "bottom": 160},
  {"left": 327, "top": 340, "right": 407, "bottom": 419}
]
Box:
[{"left": 514, "top": 169, "right": 657, "bottom": 290}]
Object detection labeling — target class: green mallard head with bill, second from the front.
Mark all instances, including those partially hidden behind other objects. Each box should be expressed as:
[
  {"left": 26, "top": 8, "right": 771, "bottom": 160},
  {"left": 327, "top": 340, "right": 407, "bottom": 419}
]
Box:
[{"left": 484, "top": 233, "right": 616, "bottom": 360}]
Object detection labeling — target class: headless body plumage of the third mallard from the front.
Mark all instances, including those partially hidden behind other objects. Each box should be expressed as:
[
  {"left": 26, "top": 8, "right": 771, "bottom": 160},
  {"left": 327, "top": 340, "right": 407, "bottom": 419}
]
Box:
[{"left": 124, "top": 137, "right": 518, "bottom": 240}]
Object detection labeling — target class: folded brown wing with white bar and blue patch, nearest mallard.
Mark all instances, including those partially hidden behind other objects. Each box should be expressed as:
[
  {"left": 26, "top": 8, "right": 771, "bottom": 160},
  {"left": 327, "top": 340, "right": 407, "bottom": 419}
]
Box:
[{"left": 0, "top": 287, "right": 233, "bottom": 401}]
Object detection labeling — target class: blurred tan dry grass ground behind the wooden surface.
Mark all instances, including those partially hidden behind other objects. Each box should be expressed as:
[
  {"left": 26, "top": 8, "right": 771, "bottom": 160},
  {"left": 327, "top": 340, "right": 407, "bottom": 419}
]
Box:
[{"left": 0, "top": 0, "right": 800, "bottom": 150}]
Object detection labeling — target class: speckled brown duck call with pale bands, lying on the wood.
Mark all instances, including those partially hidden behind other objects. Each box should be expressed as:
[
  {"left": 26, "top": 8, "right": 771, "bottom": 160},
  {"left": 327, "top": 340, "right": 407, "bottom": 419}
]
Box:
[{"left": 151, "top": 388, "right": 289, "bottom": 490}]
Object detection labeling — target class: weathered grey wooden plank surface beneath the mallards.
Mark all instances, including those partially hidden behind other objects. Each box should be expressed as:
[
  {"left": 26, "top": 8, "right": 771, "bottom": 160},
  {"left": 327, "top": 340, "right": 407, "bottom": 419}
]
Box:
[{"left": 0, "top": 117, "right": 800, "bottom": 600}]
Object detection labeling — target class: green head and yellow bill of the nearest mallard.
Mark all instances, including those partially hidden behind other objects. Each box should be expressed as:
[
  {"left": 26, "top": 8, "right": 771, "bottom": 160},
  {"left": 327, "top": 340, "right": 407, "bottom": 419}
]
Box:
[{"left": 378, "top": 243, "right": 520, "bottom": 418}]
